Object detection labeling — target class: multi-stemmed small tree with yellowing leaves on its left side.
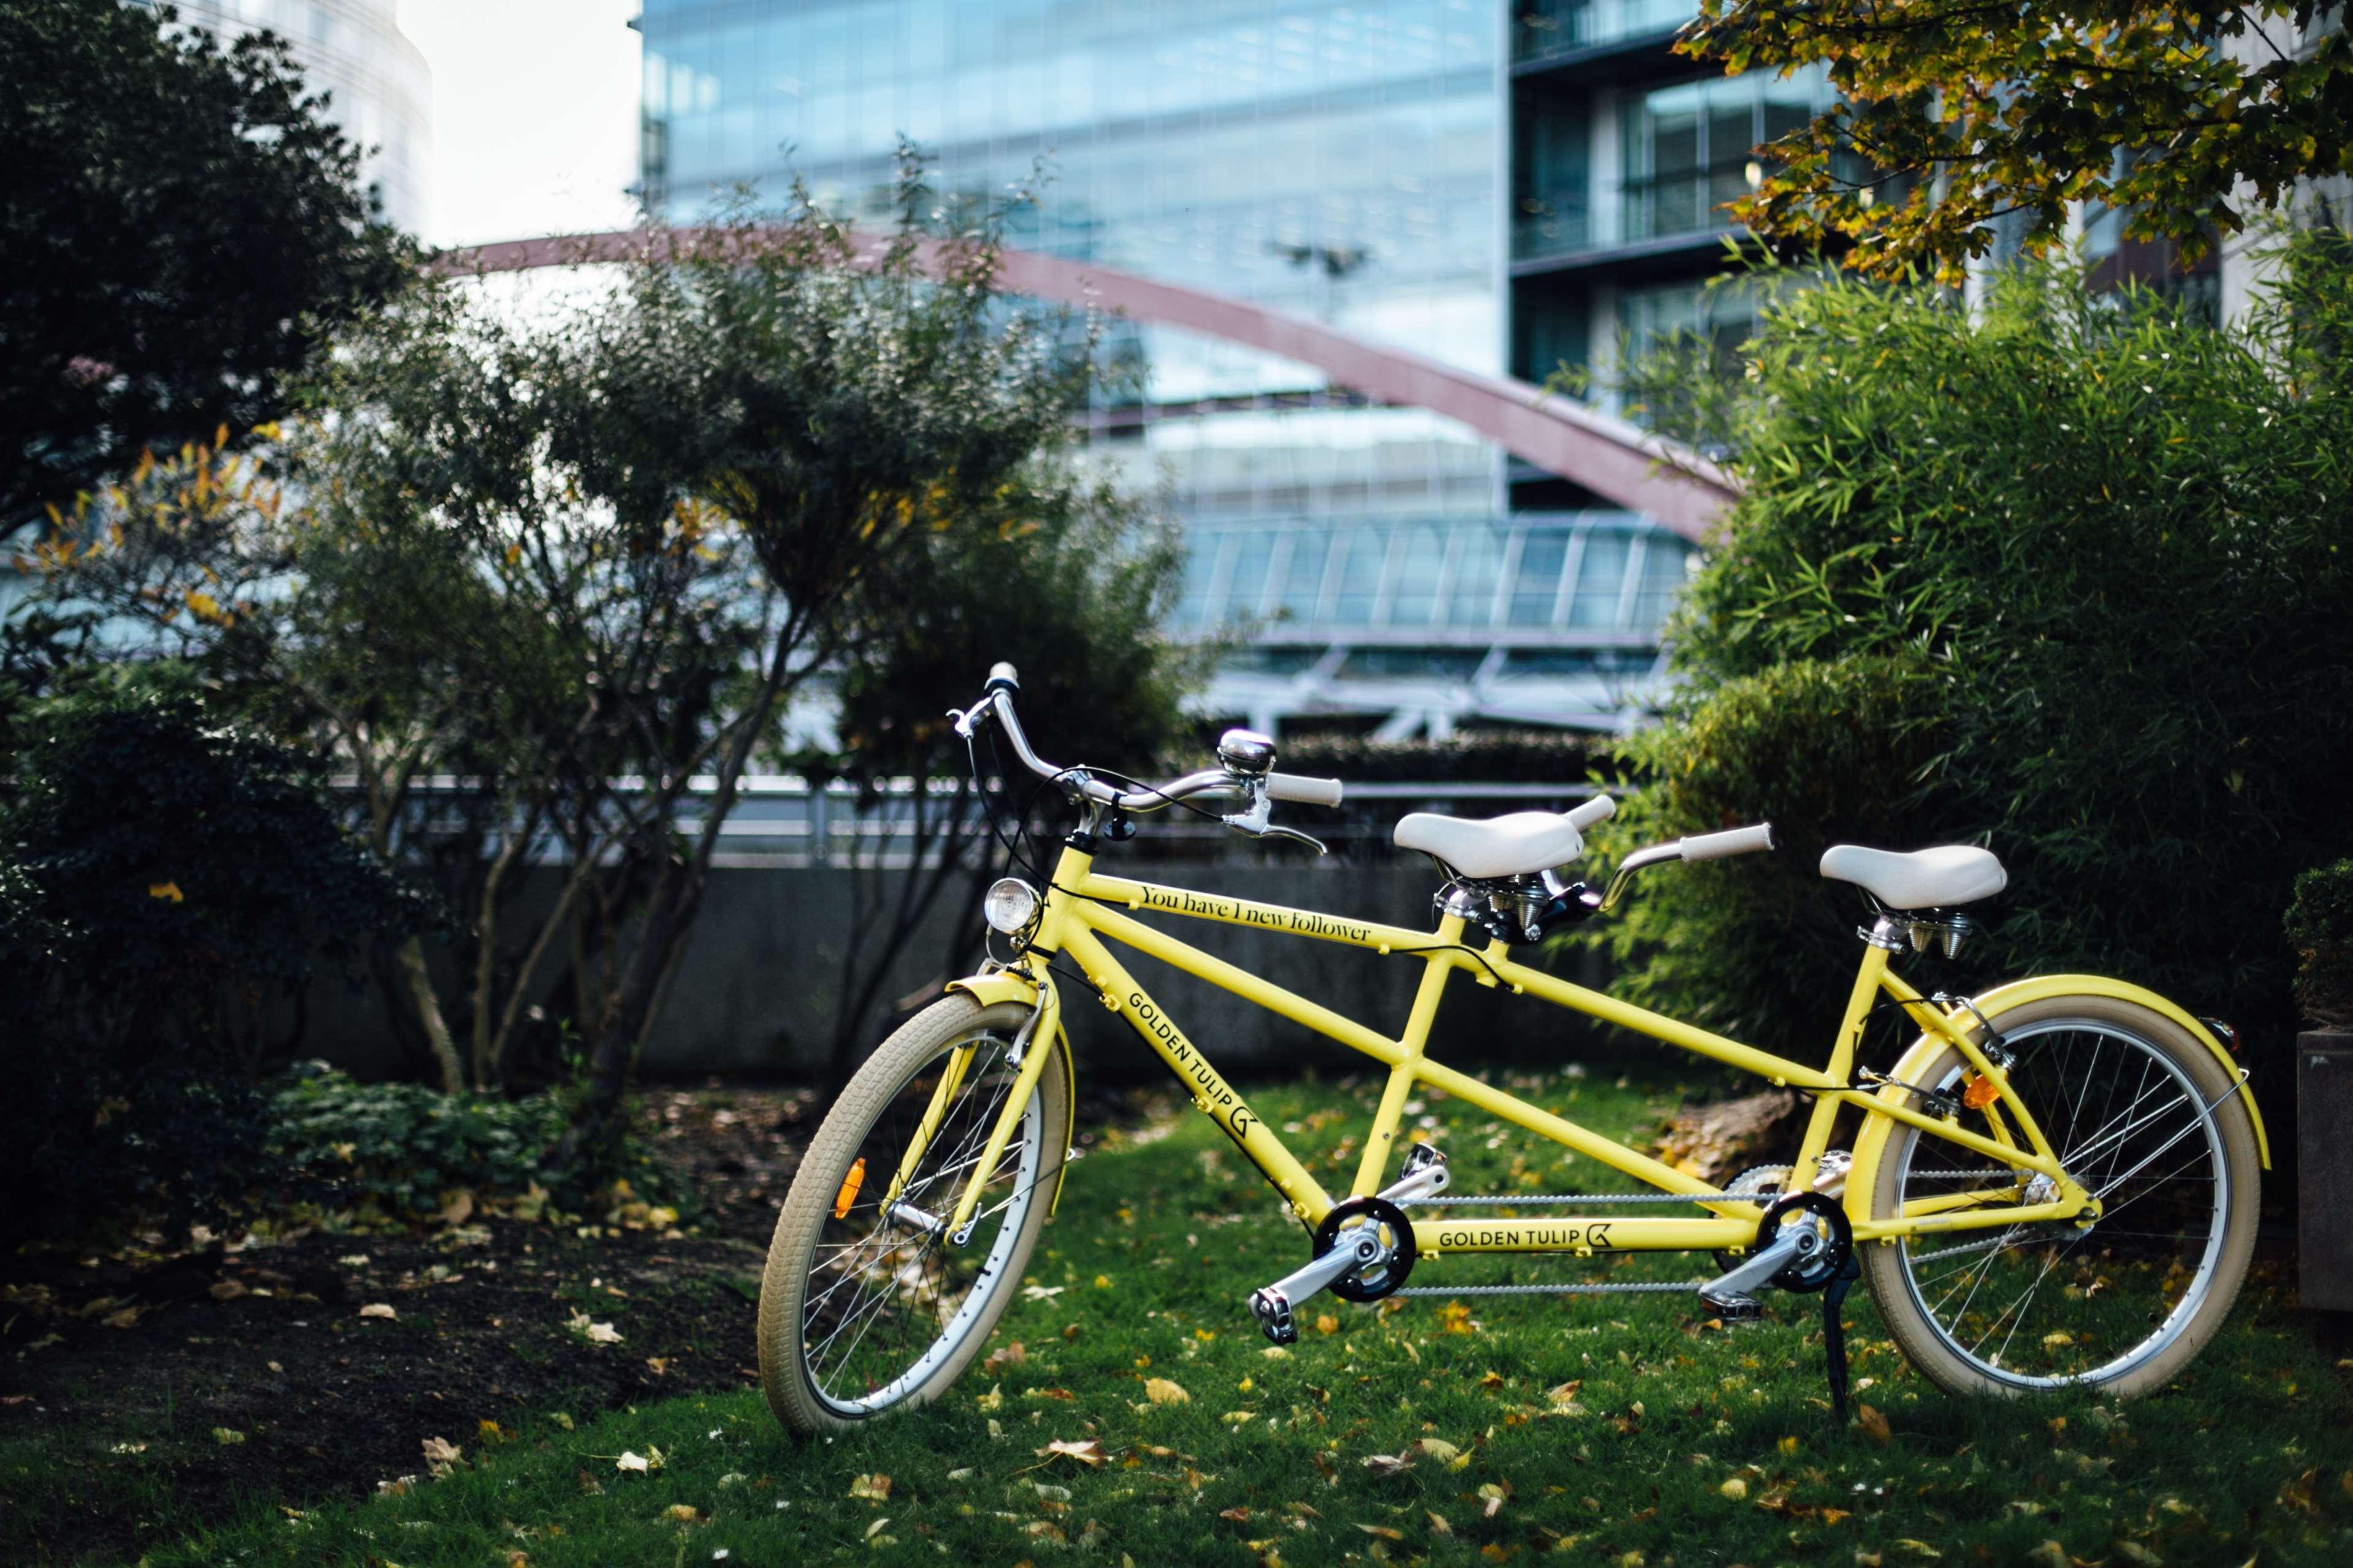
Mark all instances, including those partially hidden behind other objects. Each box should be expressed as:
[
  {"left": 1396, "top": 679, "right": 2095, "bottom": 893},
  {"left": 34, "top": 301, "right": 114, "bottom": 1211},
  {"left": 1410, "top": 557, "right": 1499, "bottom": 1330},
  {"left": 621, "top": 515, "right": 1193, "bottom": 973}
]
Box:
[{"left": 31, "top": 282, "right": 777, "bottom": 1093}]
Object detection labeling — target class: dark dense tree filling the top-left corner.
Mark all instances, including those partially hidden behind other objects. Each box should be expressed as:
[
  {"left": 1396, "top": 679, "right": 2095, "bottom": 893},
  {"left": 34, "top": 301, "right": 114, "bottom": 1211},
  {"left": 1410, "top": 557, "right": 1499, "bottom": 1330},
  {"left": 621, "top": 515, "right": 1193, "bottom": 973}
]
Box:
[{"left": 0, "top": 0, "right": 402, "bottom": 539}]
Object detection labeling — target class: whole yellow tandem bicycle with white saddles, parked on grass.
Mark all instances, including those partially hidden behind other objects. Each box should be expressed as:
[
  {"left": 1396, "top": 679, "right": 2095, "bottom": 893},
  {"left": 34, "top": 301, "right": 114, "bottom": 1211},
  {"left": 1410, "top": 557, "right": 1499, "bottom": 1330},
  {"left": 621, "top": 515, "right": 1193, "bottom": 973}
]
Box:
[{"left": 758, "top": 665, "right": 2271, "bottom": 1434}]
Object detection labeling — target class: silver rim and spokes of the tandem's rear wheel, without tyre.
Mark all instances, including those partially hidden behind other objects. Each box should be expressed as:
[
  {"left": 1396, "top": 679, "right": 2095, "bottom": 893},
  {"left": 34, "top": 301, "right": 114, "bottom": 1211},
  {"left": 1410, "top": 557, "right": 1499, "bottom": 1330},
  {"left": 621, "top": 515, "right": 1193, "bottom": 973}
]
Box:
[{"left": 1896, "top": 1018, "right": 2230, "bottom": 1389}]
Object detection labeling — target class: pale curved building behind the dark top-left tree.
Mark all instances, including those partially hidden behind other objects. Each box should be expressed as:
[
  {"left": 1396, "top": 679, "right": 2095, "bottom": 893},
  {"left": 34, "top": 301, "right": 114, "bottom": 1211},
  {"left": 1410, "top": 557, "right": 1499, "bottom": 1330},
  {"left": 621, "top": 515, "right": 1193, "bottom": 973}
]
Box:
[{"left": 146, "top": 0, "right": 433, "bottom": 233}]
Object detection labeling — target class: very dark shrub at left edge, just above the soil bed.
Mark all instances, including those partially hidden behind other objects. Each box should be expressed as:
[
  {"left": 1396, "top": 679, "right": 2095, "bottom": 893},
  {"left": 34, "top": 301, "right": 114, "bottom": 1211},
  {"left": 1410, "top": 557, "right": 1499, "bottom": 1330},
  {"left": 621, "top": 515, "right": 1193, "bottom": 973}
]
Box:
[{"left": 0, "top": 680, "right": 417, "bottom": 1241}]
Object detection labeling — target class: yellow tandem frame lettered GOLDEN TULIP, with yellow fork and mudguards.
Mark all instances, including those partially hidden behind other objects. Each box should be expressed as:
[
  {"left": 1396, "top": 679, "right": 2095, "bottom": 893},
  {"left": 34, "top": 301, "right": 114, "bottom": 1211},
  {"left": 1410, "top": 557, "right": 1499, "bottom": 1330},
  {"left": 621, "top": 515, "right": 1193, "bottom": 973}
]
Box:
[{"left": 951, "top": 846, "right": 2271, "bottom": 1258}]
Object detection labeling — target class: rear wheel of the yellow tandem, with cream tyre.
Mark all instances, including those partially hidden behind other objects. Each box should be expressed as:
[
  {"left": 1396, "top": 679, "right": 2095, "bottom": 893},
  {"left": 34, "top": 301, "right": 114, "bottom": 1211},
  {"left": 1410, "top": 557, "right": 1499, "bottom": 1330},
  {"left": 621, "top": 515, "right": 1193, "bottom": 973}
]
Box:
[{"left": 1857, "top": 997, "right": 2259, "bottom": 1399}]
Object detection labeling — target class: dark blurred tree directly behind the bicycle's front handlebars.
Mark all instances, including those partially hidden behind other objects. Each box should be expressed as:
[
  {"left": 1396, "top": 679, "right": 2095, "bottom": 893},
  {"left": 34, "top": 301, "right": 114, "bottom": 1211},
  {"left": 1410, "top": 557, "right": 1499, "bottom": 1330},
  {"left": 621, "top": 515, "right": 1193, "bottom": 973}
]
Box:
[{"left": 796, "top": 484, "right": 1212, "bottom": 1079}]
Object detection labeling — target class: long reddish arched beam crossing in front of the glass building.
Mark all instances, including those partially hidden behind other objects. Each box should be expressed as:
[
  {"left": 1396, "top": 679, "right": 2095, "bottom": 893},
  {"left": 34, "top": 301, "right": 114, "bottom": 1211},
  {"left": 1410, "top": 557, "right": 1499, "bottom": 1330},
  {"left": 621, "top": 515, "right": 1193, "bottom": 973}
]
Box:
[{"left": 438, "top": 228, "right": 1739, "bottom": 540}]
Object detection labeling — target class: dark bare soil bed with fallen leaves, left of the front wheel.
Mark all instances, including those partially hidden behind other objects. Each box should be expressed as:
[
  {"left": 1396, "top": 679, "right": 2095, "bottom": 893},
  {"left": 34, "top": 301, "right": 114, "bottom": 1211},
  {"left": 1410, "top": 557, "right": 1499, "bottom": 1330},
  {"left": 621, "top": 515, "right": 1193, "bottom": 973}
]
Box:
[{"left": 0, "top": 1088, "right": 821, "bottom": 1561}]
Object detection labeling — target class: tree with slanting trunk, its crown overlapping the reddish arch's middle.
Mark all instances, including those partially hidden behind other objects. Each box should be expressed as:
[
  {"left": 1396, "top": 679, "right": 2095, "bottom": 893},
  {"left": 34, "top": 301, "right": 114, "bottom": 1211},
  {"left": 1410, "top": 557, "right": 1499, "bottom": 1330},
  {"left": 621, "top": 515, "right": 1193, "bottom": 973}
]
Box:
[{"left": 525, "top": 165, "right": 1097, "bottom": 1161}]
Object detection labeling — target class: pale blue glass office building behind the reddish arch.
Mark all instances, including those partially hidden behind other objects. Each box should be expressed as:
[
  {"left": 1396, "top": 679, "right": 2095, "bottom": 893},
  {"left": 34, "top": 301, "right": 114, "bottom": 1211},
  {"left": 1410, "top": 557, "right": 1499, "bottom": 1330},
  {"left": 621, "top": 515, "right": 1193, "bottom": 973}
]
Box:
[{"left": 637, "top": 0, "right": 1689, "bottom": 736}]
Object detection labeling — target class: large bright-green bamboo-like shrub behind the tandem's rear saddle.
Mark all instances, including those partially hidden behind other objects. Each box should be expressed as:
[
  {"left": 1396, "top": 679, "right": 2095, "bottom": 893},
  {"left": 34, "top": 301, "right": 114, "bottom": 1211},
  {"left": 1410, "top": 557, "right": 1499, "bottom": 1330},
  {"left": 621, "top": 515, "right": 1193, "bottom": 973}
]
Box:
[{"left": 1581, "top": 237, "right": 2353, "bottom": 1067}]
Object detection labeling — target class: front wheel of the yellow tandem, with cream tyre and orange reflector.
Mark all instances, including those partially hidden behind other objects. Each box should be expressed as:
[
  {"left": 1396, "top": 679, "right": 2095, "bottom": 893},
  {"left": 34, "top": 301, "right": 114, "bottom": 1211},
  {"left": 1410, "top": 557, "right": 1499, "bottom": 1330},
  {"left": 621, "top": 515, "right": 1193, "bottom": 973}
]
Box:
[{"left": 760, "top": 994, "right": 1071, "bottom": 1434}]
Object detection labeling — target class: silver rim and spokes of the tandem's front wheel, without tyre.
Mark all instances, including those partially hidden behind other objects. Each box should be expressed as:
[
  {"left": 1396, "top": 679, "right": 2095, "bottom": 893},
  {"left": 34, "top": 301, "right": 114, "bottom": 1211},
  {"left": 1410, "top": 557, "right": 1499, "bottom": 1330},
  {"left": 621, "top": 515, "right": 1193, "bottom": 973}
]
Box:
[{"left": 793, "top": 1034, "right": 1045, "bottom": 1417}]
